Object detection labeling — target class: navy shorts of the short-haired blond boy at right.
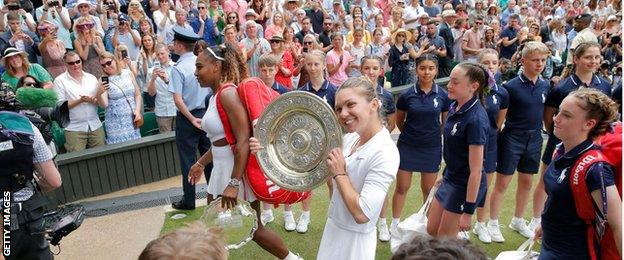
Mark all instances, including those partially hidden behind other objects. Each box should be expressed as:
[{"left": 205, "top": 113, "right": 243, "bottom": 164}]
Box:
[{"left": 496, "top": 129, "right": 542, "bottom": 175}]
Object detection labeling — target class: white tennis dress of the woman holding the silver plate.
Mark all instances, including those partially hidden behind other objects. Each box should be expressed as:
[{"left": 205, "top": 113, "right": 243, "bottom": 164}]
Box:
[{"left": 316, "top": 128, "right": 399, "bottom": 260}]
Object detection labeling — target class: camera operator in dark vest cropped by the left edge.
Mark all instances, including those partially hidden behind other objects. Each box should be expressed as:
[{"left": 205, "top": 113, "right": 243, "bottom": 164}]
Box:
[{"left": 0, "top": 86, "right": 61, "bottom": 259}]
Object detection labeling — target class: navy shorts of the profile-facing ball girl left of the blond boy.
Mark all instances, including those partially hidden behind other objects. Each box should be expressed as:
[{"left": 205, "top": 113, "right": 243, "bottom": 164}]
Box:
[{"left": 435, "top": 180, "right": 487, "bottom": 214}]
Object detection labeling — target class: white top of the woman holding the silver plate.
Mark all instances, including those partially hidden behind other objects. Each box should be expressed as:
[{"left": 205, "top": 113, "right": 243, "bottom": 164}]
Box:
[{"left": 328, "top": 128, "right": 399, "bottom": 233}]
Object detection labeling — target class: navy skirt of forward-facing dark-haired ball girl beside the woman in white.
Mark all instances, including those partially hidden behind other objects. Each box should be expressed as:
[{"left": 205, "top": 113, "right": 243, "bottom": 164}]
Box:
[{"left": 397, "top": 142, "right": 442, "bottom": 172}]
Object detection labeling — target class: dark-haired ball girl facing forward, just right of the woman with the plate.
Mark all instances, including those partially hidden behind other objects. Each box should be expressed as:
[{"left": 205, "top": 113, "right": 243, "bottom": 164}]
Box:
[{"left": 391, "top": 54, "right": 450, "bottom": 233}]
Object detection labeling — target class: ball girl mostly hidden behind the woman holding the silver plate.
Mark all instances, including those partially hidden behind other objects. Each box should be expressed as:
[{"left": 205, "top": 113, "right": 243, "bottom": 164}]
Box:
[{"left": 360, "top": 55, "right": 396, "bottom": 242}]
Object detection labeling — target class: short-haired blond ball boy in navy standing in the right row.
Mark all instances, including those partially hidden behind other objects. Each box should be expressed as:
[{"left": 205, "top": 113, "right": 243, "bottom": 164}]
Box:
[{"left": 488, "top": 41, "right": 550, "bottom": 242}]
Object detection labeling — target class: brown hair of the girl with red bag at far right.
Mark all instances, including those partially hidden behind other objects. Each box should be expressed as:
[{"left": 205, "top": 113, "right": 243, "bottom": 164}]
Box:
[{"left": 570, "top": 88, "right": 618, "bottom": 139}]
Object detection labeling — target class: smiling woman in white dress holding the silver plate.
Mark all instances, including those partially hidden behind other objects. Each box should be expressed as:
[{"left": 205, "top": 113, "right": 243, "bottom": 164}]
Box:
[{"left": 250, "top": 77, "right": 399, "bottom": 260}]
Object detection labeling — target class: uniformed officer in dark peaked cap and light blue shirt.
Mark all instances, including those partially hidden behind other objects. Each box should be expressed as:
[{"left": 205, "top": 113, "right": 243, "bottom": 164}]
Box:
[{"left": 168, "top": 27, "right": 212, "bottom": 210}]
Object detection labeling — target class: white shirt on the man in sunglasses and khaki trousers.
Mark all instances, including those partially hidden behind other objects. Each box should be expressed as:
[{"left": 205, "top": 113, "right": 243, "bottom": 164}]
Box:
[{"left": 54, "top": 71, "right": 102, "bottom": 132}]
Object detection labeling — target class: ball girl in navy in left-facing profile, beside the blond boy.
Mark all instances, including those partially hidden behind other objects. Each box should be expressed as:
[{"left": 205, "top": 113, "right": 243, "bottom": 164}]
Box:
[{"left": 427, "top": 63, "right": 490, "bottom": 238}]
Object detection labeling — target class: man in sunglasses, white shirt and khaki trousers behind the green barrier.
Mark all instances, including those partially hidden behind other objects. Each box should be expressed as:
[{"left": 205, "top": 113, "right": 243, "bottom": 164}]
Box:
[{"left": 54, "top": 51, "right": 107, "bottom": 152}]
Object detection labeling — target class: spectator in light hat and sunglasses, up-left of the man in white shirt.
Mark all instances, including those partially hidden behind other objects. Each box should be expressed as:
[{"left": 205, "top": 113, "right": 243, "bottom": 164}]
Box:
[{"left": 37, "top": 21, "right": 67, "bottom": 78}]
